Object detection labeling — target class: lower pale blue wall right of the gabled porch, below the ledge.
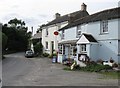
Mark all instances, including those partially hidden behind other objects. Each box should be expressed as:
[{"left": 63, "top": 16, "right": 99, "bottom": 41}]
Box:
[{"left": 98, "top": 40, "right": 118, "bottom": 62}]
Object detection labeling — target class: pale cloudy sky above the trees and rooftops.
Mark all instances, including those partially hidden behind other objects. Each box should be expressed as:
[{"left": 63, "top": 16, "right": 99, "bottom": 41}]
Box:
[{"left": 0, "top": 0, "right": 120, "bottom": 34}]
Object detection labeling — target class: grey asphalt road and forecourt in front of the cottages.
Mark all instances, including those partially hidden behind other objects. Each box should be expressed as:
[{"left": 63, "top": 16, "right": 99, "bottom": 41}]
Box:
[{"left": 2, "top": 53, "right": 118, "bottom": 86}]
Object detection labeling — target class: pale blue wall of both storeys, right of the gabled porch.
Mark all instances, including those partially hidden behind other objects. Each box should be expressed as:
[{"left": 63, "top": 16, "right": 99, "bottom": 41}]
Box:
[{"left": 77, "top": 19, "right": 120, "bottom": 61}]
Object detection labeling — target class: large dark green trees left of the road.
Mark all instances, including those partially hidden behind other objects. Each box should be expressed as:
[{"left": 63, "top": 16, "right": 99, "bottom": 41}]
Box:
[{"left": 2, "top": 18, "right": 31, "bottom": 52}]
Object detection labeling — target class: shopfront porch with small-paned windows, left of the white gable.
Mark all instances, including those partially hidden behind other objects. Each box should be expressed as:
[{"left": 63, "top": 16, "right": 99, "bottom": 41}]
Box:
[{"left": 58, "top": 40, "right": 77, "bottom": 64}]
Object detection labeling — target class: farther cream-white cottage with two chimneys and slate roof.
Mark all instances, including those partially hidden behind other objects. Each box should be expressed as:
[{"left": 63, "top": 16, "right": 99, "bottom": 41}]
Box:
[{"left": 42, "top": 4, "right": 89, "bottom": 54}]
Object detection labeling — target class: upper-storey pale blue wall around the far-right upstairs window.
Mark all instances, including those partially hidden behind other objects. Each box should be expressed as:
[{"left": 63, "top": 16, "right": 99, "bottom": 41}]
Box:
[{"left": 82, "top": 19, "right": 118, "bottom": 40}]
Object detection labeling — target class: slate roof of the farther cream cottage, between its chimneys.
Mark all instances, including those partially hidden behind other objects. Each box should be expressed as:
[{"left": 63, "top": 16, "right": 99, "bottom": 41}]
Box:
[{"left": 44, "top": 10, "right": 89, "bottom": 26}]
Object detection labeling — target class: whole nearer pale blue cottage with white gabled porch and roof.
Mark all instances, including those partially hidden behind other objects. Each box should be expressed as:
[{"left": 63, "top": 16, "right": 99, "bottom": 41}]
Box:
[{"left": 58, "top": 7, "right": 120, "bottom": 64}]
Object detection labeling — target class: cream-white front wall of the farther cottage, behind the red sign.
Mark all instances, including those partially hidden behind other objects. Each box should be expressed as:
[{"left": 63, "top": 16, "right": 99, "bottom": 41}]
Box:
[{"left": 42, "top": 22, "right": 68, "bottom": 54}]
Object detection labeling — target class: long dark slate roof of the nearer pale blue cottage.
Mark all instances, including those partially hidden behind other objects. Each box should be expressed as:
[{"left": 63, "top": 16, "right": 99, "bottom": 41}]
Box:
[{"left": 59, "top": 7, "right": 120, "bottom": 31}]
